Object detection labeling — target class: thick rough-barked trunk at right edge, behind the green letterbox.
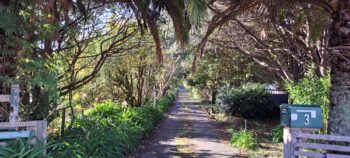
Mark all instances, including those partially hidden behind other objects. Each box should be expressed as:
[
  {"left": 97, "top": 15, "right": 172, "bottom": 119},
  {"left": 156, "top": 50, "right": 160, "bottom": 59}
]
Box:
[{"left": 328, "top": 0, "right": 350, "bottom": 135}]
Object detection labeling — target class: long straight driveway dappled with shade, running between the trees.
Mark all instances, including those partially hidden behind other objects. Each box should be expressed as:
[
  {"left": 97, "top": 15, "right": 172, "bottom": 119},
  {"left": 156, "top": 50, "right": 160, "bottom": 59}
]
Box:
[{"left": 134, "top": 88, "right": 239, "bottom": 158}]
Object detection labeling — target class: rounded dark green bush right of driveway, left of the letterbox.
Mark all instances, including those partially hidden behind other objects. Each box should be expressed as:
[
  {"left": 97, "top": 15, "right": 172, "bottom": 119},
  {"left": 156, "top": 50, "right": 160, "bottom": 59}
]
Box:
[{"left": 217, "top": 83, "right": 278, "bottom": 118}]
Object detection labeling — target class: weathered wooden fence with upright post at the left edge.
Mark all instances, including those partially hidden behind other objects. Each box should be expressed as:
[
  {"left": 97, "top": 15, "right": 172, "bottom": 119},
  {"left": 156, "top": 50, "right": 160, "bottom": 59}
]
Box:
[{"left": 0, "top": 84, "right": 47, "bottom": 145}]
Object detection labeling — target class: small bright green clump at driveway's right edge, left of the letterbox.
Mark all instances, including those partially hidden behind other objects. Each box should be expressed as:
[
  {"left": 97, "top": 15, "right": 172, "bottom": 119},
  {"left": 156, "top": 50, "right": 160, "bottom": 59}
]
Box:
[{"left": 230, "top": 130, "right": 258, "bottom": 151}]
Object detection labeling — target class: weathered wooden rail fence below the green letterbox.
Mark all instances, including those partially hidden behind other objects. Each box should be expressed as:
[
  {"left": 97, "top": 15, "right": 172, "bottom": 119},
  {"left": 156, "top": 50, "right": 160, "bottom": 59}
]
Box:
[{"left": 283, "top": 127, "right": 350, "bottom": 158}]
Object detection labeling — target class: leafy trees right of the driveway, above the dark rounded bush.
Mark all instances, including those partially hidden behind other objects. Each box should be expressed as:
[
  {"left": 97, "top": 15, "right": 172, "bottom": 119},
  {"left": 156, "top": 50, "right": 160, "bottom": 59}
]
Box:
[{"left": 187, "top": 45, "right": 278, "bottom": 102}]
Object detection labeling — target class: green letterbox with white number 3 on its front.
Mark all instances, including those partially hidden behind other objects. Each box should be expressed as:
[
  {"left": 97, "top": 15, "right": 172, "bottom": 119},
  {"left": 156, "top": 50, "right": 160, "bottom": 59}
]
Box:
[{"left": 280, "top": 104, "right": 322, "bottom": 128}]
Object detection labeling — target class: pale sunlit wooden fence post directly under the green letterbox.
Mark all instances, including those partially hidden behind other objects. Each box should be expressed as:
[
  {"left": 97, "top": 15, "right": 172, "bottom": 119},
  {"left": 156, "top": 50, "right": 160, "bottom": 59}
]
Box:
[{"left": 283, "top": 127, "right": 296, "bottom": 158}]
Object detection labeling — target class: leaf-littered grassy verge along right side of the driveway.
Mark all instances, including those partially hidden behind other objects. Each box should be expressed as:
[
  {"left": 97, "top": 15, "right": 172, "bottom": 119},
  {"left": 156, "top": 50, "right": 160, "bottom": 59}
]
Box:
[{"left": 201, "top": 102, "right": 283, "bottom": 158}]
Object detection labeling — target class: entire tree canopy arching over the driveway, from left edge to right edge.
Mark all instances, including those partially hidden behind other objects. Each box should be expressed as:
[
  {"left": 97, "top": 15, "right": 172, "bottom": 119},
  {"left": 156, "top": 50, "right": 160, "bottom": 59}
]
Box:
[{"left": 0, "top": 0, "right": 350, "bottom": 135}]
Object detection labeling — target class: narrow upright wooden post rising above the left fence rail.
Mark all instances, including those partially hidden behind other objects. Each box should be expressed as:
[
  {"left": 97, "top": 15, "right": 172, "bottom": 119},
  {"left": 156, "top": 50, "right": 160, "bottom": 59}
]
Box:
[{"left": 9, "top": 84, "right": 20, "bottom": 122}]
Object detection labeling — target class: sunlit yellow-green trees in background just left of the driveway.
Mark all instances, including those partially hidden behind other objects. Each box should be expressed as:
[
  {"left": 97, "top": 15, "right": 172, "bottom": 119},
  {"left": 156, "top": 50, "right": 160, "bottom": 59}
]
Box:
[{"left": 79, "top": 28, "right": 183, "bottom": 107}]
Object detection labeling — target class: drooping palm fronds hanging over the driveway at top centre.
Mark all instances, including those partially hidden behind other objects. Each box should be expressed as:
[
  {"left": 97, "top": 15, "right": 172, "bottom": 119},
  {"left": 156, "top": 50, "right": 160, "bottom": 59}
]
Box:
[{"left": 127, "top": 0, "right": 206, "bottom": 63}]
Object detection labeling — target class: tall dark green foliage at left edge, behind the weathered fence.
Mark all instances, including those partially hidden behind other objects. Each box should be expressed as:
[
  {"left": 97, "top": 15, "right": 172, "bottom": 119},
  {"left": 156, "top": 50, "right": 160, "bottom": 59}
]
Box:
[{"left": 0, "top": 0, "right": 58, "bottom": 120}]
